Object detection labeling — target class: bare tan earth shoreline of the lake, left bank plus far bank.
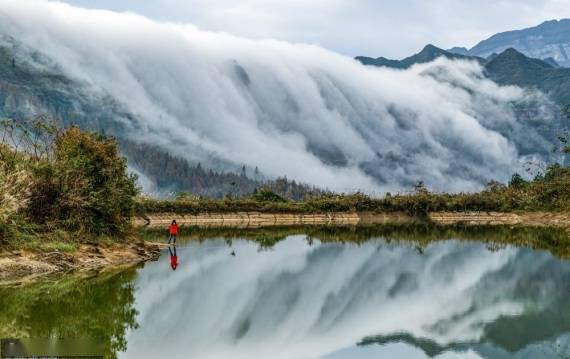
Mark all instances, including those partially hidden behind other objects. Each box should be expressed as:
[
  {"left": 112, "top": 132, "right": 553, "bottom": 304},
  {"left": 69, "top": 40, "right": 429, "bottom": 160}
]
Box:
[{"left": 0, "top": 212, "right": 570, "bottom": 286}]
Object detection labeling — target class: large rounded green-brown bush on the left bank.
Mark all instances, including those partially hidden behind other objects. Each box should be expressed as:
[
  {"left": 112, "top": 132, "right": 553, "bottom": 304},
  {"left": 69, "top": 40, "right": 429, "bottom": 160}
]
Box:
[{"left": 28, "top": 127, "right": 137, "bottom": 235}]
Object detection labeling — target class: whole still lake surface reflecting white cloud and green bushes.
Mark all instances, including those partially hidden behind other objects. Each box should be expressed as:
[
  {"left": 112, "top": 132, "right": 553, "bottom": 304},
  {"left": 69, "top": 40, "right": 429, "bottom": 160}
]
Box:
[{"left": 0, "top": 229, "right": 570, "bottom": 359}]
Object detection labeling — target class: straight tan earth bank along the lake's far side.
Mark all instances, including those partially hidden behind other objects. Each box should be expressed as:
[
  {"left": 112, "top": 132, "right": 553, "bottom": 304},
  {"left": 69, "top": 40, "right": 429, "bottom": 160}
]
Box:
[{"left": 133, "top": 211, "right": 570, "bottom": 228}]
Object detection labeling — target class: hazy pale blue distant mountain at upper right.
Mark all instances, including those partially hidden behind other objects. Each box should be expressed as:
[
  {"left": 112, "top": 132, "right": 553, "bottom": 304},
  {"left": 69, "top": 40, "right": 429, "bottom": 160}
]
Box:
[{"left": 468, "top": 19, "right": 570, "bottom": 67}]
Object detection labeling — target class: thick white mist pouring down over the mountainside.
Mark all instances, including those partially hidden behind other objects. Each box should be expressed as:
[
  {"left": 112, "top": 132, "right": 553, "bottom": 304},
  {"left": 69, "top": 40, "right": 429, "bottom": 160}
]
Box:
[{"left": 0, "top": 0, "right": 550, "bottom": 193}]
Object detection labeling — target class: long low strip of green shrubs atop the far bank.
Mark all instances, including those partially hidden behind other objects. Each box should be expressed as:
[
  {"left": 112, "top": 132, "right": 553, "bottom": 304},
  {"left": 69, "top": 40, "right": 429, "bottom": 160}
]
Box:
[{"left": 138, "top": 165, "right": 570, "bottom": 216}]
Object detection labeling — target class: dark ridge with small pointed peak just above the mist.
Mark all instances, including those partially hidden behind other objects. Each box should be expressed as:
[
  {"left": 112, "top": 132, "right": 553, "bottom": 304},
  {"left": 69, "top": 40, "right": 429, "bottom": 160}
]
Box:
[{"left": 356, "top": 44, "right": 485, "bottom": 69}]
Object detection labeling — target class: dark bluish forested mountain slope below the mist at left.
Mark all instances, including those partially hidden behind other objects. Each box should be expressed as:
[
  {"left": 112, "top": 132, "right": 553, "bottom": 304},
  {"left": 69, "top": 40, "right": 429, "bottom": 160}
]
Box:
[{"left": 0, "top": 36, "right": 322, "bottom": 200}]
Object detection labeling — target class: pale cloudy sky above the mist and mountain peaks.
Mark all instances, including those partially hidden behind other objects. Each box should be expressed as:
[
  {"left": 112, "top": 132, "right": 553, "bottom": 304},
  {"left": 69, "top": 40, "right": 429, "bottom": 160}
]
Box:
[{"left": 56, "top": 0, "right": 570, "bottom": 58}]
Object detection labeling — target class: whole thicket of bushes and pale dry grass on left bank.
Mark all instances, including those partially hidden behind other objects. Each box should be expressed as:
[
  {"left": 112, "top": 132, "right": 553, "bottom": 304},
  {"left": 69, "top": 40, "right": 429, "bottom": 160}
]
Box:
[{"left": 0, "top": 121, "right": 137, "bottom": 248}]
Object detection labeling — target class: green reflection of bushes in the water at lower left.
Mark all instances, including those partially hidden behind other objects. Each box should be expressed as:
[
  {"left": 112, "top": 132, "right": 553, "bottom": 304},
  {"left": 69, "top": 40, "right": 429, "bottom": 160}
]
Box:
[{"left": 0, "top": 268, "right": 138, "bottom": 358}]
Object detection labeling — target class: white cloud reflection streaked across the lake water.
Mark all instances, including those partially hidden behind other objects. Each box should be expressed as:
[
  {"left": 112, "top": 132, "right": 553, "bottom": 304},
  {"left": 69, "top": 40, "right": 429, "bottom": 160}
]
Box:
[{"left": 122, "top": 236, "right": 570, "bottom": 358}]
